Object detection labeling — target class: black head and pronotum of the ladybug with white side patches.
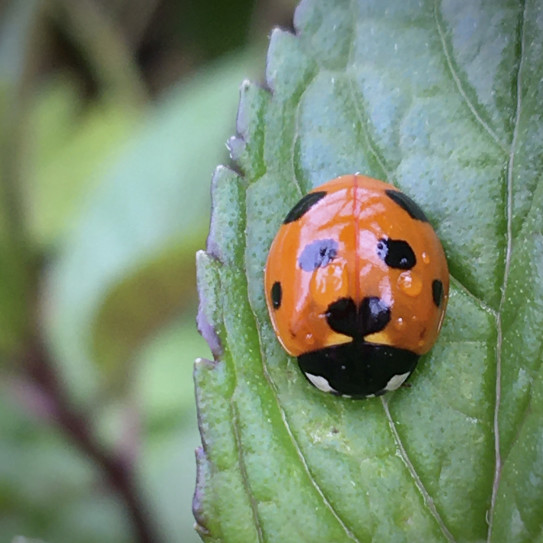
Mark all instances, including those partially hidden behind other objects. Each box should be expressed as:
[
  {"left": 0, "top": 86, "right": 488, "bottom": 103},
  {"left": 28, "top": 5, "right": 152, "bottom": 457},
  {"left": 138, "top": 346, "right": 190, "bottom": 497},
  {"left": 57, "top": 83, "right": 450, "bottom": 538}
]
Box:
[{"left": 298, "top": 339, "right": 419, "bottom": 398}]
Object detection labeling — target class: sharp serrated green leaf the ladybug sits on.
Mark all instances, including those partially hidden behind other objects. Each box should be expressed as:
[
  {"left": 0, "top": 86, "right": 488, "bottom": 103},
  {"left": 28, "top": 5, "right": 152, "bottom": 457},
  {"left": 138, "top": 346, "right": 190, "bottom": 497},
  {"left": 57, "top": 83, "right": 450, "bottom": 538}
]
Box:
[{"left": 194, "top": 0, "right": 543, "bottom": 543}]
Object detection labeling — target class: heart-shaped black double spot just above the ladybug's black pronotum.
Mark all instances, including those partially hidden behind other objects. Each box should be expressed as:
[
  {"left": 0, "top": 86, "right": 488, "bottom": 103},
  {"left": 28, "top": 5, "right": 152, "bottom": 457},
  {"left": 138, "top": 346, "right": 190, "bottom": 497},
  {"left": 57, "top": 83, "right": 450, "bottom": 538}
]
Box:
[{"left": 325, "top": 296, "right": 390, "bottom": 338}]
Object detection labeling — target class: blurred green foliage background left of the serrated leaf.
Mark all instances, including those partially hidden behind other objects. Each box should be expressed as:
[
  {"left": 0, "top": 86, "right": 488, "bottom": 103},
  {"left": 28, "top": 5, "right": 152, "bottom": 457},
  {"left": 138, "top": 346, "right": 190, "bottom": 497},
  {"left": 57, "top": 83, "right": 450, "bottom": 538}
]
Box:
[{"left": 0, "top": 0, "right": 294, "bottom": 543}]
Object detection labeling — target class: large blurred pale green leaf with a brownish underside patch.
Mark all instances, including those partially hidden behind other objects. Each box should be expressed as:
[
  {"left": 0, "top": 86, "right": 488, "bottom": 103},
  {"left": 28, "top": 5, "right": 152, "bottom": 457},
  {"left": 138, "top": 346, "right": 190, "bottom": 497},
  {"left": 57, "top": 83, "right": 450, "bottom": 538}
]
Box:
[{"left": 45, "top": 51, "right": 256, "bottom": 398}]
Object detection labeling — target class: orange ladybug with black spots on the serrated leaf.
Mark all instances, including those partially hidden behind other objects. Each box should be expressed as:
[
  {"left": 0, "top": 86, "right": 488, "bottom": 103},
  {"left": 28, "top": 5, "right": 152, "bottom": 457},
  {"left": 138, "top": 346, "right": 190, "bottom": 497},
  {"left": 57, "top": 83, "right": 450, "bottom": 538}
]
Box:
[{"left": 265, "top": 175, "right": 449, "bottom": 398}]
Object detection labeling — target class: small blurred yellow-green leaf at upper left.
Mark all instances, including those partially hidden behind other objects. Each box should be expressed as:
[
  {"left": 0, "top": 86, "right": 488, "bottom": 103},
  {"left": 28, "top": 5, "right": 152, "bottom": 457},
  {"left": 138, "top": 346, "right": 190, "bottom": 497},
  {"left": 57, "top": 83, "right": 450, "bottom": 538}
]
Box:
[{"left": 26, "top": 75, "right": 143, "bottom": 248}]
